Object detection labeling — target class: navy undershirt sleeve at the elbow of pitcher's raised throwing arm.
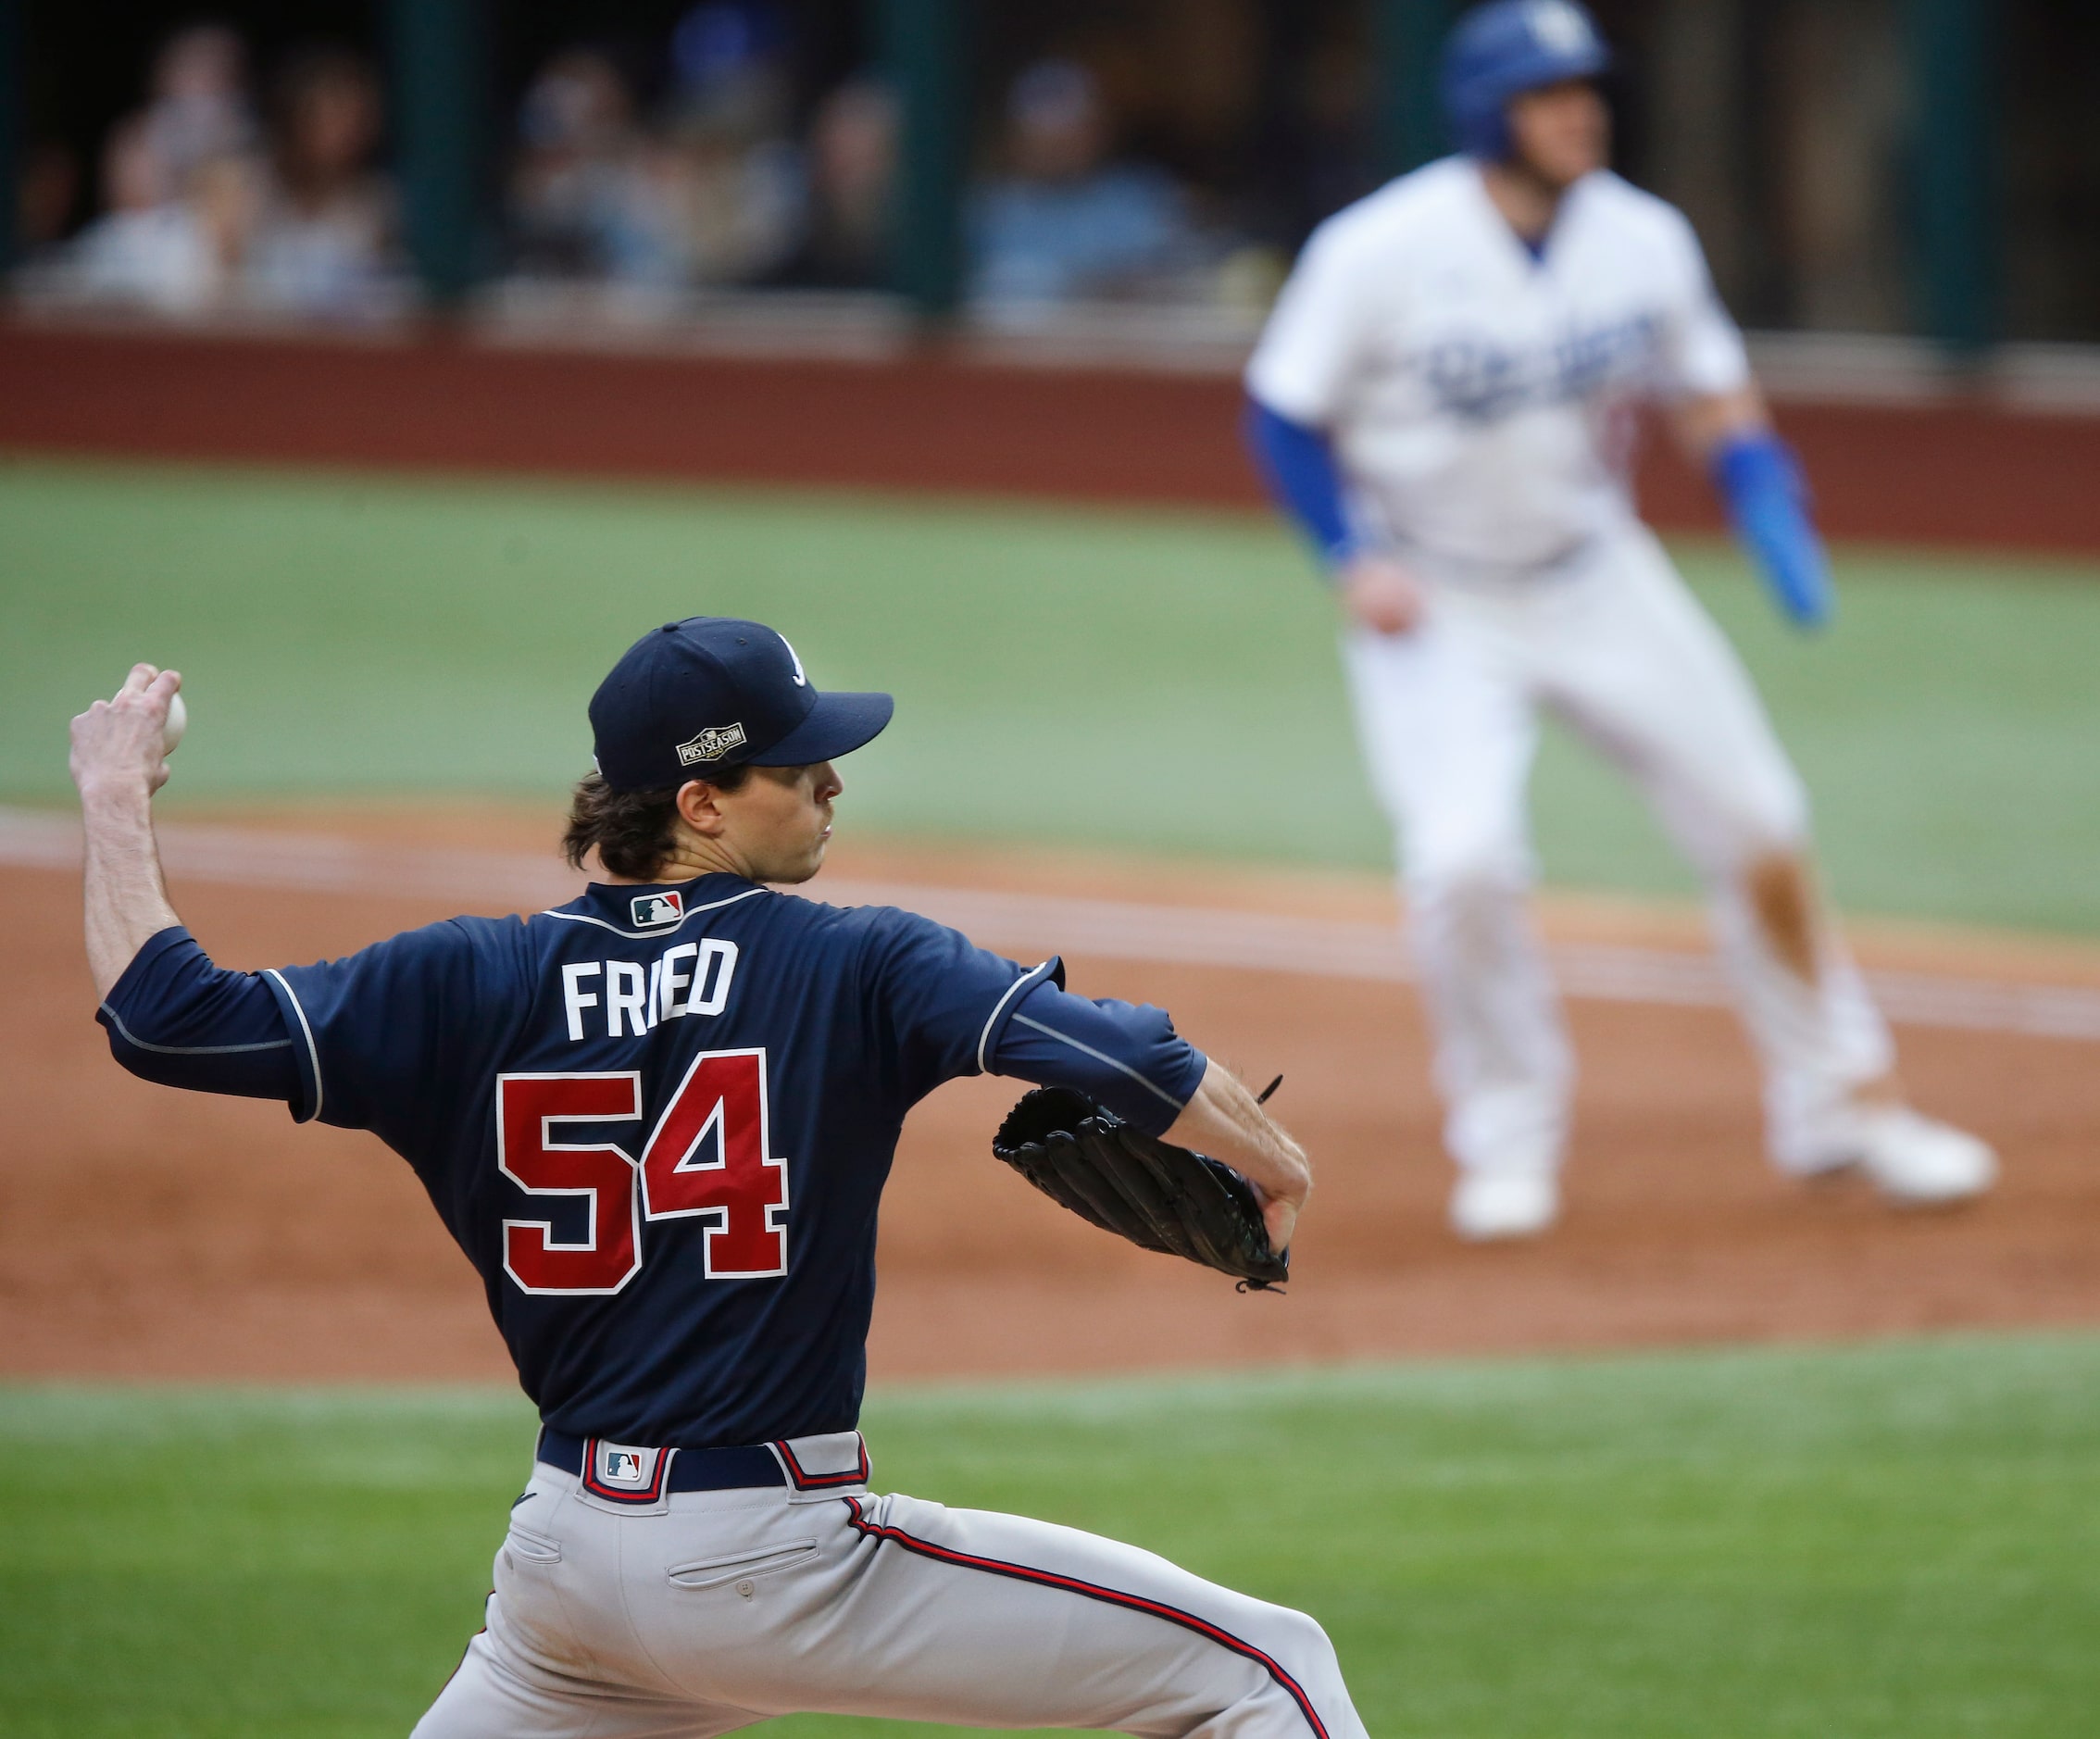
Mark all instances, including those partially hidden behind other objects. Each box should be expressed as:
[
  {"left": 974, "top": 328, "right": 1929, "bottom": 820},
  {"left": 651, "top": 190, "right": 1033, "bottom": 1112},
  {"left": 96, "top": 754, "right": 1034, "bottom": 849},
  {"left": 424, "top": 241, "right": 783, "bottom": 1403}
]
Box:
[{"left": 94, "top": 924, "right": 298, "bottom": 1103}]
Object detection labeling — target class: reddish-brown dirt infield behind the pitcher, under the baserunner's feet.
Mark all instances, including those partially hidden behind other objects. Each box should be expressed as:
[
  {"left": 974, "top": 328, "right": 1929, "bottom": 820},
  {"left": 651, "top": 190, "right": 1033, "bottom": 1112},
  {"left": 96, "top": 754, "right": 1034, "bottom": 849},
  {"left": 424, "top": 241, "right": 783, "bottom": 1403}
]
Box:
[{"left": 0, "top": 810, "right": 2100, "bottom": 1380}]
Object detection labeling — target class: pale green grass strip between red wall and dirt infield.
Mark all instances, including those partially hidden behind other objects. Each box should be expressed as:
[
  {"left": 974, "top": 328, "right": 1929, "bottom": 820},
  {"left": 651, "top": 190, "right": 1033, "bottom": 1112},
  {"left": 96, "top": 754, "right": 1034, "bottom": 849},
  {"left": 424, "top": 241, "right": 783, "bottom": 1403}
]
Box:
[{"left": 0, "top": 460, "right": 2100, "bottom": 932}]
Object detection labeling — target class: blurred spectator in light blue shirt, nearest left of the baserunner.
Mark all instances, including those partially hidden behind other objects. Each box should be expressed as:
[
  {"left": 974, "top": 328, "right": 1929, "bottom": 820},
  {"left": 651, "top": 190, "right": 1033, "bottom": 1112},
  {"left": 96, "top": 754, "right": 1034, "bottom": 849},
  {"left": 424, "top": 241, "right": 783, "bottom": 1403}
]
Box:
[{"left": 970, "top": 61, "right": 1204, "bottom": 308}]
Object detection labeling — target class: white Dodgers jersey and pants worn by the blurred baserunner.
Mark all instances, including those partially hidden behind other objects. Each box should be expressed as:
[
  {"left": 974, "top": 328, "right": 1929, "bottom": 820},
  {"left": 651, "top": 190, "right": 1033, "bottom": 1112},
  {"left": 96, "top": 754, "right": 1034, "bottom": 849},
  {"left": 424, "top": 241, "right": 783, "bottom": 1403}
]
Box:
[{"left": 1247, "top": 157, "right": 1892, "bottom": 1170}]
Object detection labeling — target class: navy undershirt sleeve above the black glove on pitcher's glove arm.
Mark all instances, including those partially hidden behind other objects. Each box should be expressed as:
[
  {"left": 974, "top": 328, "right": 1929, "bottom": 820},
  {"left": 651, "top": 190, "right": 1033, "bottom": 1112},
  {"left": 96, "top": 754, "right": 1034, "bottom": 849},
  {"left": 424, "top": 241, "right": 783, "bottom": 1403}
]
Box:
[{"left": 987, "top": 977, "right": 1209, "bottom": 1136}]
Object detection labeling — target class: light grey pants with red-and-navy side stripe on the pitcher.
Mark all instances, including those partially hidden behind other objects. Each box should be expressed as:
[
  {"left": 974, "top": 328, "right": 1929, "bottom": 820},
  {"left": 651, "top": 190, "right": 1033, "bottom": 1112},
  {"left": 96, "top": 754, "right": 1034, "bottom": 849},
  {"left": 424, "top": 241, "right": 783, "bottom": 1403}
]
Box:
[{"left": 416, "top": 1439, "right": 1363, "bottom": 1739}]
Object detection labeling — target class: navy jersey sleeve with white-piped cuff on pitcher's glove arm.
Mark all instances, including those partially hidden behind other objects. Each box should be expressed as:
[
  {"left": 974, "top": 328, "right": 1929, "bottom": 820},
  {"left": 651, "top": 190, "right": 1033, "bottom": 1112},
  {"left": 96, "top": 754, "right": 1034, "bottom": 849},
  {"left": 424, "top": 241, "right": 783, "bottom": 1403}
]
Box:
[{"left": 868, "top": 907, "right": 1065, "bottom": 1100}]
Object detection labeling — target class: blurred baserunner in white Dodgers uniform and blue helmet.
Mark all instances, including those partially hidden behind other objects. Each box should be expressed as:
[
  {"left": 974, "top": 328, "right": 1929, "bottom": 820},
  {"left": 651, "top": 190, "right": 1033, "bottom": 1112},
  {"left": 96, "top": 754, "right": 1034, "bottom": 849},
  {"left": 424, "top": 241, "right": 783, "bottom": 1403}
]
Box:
[{"left": 1247, "top": 0, "right": 1995, "bottom": 1239}]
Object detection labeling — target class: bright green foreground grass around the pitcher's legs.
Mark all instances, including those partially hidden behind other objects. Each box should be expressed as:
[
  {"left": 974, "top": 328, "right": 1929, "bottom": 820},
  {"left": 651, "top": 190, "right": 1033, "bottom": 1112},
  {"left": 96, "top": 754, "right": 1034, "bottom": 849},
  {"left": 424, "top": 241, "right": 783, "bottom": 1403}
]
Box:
[{"left": 0, "top": 1336, "right": 2100, "bottom": 1739}]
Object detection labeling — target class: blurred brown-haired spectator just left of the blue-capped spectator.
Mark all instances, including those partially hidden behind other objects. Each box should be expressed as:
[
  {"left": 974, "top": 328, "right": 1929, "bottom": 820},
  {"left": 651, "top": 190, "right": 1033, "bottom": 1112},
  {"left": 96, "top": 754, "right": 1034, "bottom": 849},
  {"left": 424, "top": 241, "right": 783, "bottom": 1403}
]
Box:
[{"left": 510, "top": 48, "right": 689, "bottom": 288}]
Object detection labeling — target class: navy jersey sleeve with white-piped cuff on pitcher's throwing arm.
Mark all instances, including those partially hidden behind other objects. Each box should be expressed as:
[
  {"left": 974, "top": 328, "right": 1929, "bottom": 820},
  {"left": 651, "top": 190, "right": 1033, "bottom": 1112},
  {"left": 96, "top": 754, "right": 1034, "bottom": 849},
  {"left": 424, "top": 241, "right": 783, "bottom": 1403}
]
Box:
[{"left": 263, "top": 920, "right": 495, "bottom": 1141}]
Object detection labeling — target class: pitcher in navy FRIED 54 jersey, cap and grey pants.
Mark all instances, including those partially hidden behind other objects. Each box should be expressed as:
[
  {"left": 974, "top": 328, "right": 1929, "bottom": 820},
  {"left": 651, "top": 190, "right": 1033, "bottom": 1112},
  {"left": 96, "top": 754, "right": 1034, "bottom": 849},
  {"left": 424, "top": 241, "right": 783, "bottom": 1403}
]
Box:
[{"left": 73, "top": 618, "right": 1363, "bottom": 1739}]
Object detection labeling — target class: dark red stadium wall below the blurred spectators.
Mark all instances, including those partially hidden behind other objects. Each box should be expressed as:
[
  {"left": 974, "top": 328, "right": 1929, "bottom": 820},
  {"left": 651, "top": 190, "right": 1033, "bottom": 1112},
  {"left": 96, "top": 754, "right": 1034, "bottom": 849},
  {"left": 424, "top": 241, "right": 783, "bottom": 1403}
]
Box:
[{"left": 0, "top": 321, "right": 2100, "bottom": 553}]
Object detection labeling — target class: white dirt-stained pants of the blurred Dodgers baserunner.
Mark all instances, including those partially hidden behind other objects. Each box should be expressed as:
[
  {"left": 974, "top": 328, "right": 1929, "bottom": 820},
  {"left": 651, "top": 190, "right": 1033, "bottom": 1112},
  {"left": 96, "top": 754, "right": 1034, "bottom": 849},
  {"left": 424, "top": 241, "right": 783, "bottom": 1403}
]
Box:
[{"left": 1348, "top": 527, "right": 1894, "bottom": 1168}]
